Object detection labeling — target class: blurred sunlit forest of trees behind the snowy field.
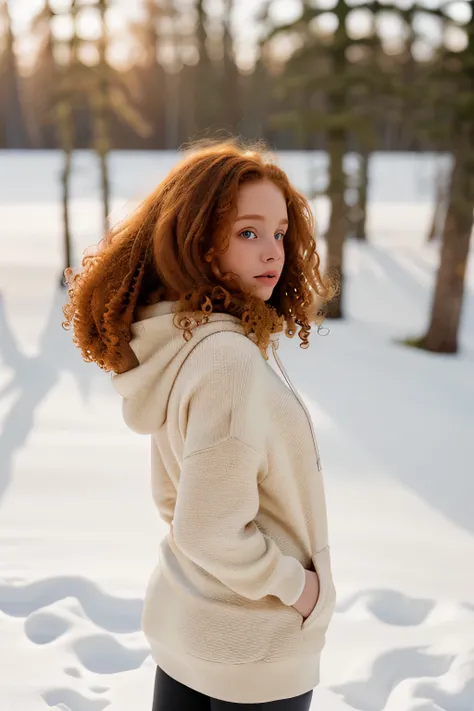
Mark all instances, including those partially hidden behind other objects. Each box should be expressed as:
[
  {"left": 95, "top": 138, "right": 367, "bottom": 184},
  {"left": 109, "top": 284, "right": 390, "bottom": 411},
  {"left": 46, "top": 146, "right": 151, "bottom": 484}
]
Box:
[{"left": 0, "top": 0, "right": 474, "bottom": 344}]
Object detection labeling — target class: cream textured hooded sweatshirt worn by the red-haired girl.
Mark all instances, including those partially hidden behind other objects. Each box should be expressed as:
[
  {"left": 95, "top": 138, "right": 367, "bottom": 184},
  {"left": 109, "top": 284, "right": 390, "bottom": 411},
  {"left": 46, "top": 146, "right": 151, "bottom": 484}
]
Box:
[{"left": 113, "top": 302, "right": 335, "bottom": 703}]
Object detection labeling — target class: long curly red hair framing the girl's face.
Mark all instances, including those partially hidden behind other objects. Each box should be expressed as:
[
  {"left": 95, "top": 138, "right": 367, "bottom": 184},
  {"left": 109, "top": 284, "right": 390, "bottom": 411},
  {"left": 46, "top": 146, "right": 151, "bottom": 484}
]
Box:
[{"left": 63, "top": 141, "right": 335, "bottom": 373}]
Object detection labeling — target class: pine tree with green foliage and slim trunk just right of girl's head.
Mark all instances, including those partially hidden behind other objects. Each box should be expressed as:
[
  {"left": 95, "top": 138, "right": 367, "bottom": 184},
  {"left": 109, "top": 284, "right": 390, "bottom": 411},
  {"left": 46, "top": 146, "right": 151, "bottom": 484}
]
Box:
[{"left": 269, "top": 0, "right": 383, "bottom": 318}]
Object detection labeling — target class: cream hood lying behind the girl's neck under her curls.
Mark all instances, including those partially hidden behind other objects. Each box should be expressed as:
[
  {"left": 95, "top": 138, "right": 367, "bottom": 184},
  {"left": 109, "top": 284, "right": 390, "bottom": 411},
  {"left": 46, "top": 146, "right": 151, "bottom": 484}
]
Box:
[{"left": 112, "top": 301, "right": 250, "bottom": 434}]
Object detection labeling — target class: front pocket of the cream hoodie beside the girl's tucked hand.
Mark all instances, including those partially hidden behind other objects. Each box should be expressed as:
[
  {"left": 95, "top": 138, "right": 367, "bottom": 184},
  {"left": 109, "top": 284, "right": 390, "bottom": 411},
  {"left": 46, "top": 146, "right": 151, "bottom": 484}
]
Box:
[{"left": 301, "top": 546, "right": 336, "bottom": 647}]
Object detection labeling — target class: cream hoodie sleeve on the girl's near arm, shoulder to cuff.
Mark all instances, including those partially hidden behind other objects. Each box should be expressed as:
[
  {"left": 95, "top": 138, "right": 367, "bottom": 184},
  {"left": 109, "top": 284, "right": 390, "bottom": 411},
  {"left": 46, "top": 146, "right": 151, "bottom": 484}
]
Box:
[{"left": 173, "top": 333, "right": 305, "bottom": 605}]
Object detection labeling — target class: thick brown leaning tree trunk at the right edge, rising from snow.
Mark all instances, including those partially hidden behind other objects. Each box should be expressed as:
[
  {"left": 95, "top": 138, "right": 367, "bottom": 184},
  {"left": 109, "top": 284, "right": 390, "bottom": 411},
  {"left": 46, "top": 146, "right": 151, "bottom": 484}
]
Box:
[{"left": 420, "top": 153, "right": 474, "bottom": 353}]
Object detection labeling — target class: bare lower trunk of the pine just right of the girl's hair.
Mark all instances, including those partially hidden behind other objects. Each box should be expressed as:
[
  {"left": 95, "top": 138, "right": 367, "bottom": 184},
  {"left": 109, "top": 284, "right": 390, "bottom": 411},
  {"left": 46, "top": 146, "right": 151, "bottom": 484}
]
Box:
[{"left": 326, "top": 129, "right": 347, "bottom": 318}]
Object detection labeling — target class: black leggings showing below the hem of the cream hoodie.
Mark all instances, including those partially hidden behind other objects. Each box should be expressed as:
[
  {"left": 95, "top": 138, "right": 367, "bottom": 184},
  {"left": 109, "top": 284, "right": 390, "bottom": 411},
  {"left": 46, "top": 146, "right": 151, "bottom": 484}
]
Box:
[{"left": 152, "top": 667, "right": 313, "bottom": 711}]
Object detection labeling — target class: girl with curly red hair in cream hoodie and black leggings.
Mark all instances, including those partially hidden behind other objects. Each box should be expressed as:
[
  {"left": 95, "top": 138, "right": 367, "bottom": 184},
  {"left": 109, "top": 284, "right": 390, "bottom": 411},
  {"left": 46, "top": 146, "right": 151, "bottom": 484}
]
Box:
[{"left": 64, "top": 143, "right": 335, "bottom": 711}]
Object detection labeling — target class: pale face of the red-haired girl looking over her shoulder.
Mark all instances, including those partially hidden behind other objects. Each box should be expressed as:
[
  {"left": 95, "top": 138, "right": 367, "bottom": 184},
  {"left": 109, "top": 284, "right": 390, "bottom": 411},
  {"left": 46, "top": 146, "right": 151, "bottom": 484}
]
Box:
[{"left": 219, "top": 180, "right": 288, "bottom": 301}]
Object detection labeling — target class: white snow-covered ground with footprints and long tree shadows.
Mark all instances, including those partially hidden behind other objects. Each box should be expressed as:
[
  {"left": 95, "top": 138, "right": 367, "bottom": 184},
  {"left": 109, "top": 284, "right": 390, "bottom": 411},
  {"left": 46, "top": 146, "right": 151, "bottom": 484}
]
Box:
[{"left": 0, "top": 153, "right": 474, "bottom": 711}]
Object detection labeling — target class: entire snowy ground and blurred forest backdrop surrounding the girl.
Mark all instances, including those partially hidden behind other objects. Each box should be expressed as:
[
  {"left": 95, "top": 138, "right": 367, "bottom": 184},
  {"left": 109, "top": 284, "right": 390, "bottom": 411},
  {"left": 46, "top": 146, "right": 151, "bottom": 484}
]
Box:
[{"left": 0, "top": 0, "right": 474, "bottom": 711}]
